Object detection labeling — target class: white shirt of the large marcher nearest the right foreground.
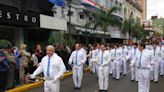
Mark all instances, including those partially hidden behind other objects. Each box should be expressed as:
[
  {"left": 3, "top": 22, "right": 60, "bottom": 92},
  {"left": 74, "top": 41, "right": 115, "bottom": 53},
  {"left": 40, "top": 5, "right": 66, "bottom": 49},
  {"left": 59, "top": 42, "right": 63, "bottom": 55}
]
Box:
[{"left": 132, "top": 49, "right": 151, "bottom": 69}]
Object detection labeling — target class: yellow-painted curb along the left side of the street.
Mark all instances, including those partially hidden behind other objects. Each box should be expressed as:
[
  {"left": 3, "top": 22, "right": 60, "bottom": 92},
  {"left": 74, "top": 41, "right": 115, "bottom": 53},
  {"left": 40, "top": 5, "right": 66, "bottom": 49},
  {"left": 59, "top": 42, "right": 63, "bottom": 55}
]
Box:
[{"left": 6, "top": 68, "right": 89, "bottom": 92}]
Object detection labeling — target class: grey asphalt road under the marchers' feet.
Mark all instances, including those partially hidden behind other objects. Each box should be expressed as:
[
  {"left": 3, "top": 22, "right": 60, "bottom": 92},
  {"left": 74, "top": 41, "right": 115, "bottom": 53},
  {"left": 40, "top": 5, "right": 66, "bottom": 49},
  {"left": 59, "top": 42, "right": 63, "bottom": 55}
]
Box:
[{"left": 27, "top": 73, "right": 164, "bottom": 92}]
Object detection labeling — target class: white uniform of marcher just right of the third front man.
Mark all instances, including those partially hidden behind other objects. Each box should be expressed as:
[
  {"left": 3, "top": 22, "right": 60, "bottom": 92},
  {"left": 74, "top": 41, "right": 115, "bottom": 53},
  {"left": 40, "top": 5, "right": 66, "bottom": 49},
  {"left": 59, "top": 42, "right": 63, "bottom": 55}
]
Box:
[{"left": 111, "top": 48, "right": 122, "bottom": 79}]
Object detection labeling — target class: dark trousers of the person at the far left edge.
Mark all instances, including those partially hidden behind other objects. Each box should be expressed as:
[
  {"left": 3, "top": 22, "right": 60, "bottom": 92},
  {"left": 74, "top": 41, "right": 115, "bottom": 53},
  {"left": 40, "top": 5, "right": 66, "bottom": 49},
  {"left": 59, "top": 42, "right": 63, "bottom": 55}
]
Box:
[{"left": 0, "top": 71, "right": 7, "bottom": 92}]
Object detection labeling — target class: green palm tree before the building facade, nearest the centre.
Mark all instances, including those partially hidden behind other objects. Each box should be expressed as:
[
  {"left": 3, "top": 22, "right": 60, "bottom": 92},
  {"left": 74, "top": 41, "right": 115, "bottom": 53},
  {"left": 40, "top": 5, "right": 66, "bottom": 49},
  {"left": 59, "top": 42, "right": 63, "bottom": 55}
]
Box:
[{"left": 86, "top": 7, "right": 121, "bottom": 42}]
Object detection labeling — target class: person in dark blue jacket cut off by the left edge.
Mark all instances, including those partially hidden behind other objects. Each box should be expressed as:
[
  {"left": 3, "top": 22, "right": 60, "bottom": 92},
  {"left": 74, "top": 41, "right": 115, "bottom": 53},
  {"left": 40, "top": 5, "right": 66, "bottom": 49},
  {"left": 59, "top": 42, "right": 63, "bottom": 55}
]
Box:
[{"left": 0, "top": 46, "right": 9, "bottom": 92}]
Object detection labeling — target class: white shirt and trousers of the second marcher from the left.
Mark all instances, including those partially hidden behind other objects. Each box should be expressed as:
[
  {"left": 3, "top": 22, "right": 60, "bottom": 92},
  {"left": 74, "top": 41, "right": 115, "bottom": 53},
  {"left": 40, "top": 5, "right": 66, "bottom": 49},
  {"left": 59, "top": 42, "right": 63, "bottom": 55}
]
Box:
[{"left": 69, "top": 50, "right": 86, "bottom": 88}]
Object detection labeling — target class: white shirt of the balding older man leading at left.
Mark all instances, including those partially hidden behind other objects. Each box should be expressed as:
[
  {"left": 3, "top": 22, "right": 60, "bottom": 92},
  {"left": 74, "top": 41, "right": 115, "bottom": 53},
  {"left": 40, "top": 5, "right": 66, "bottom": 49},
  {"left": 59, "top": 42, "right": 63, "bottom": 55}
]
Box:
[{"left": 33, "top": 53, "right": 66, "bottom": 79}]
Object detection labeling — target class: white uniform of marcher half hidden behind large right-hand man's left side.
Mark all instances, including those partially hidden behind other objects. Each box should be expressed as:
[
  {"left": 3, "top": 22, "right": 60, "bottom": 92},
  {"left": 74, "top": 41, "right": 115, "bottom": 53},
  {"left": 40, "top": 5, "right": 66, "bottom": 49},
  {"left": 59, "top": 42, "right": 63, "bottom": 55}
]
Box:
[{"left": 129, "top": 48, "right": 139, "bottom": 81}]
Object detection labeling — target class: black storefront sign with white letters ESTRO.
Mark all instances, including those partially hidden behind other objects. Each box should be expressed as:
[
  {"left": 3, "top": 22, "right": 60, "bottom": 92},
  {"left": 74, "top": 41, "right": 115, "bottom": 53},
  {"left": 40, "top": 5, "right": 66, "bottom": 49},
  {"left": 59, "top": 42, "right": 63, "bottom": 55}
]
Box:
[{"left": 0, "top": 5, "right": 40, "bottom": 27}]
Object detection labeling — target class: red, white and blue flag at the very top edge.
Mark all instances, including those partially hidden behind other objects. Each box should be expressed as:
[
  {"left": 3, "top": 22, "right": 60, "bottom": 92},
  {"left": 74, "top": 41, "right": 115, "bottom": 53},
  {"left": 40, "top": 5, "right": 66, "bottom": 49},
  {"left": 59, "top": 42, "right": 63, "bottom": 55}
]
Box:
[{"left": 80, "top": 0, "right": 97, "bottom": 8}]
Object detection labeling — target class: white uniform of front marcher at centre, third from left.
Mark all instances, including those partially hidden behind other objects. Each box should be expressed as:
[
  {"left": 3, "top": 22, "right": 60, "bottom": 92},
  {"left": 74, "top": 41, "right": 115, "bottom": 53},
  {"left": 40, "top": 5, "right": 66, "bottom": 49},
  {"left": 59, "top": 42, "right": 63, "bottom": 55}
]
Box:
[{"left": 97, "top": 51, "right": 111, "bottom": 90}]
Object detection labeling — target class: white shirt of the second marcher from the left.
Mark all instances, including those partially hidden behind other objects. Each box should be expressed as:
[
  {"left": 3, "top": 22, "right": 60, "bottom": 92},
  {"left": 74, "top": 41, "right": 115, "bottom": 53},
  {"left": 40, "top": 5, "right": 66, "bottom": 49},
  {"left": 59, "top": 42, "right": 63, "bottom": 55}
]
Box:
[{"left": 69, "top": 50, "right": 86, "bottom": 66}]
